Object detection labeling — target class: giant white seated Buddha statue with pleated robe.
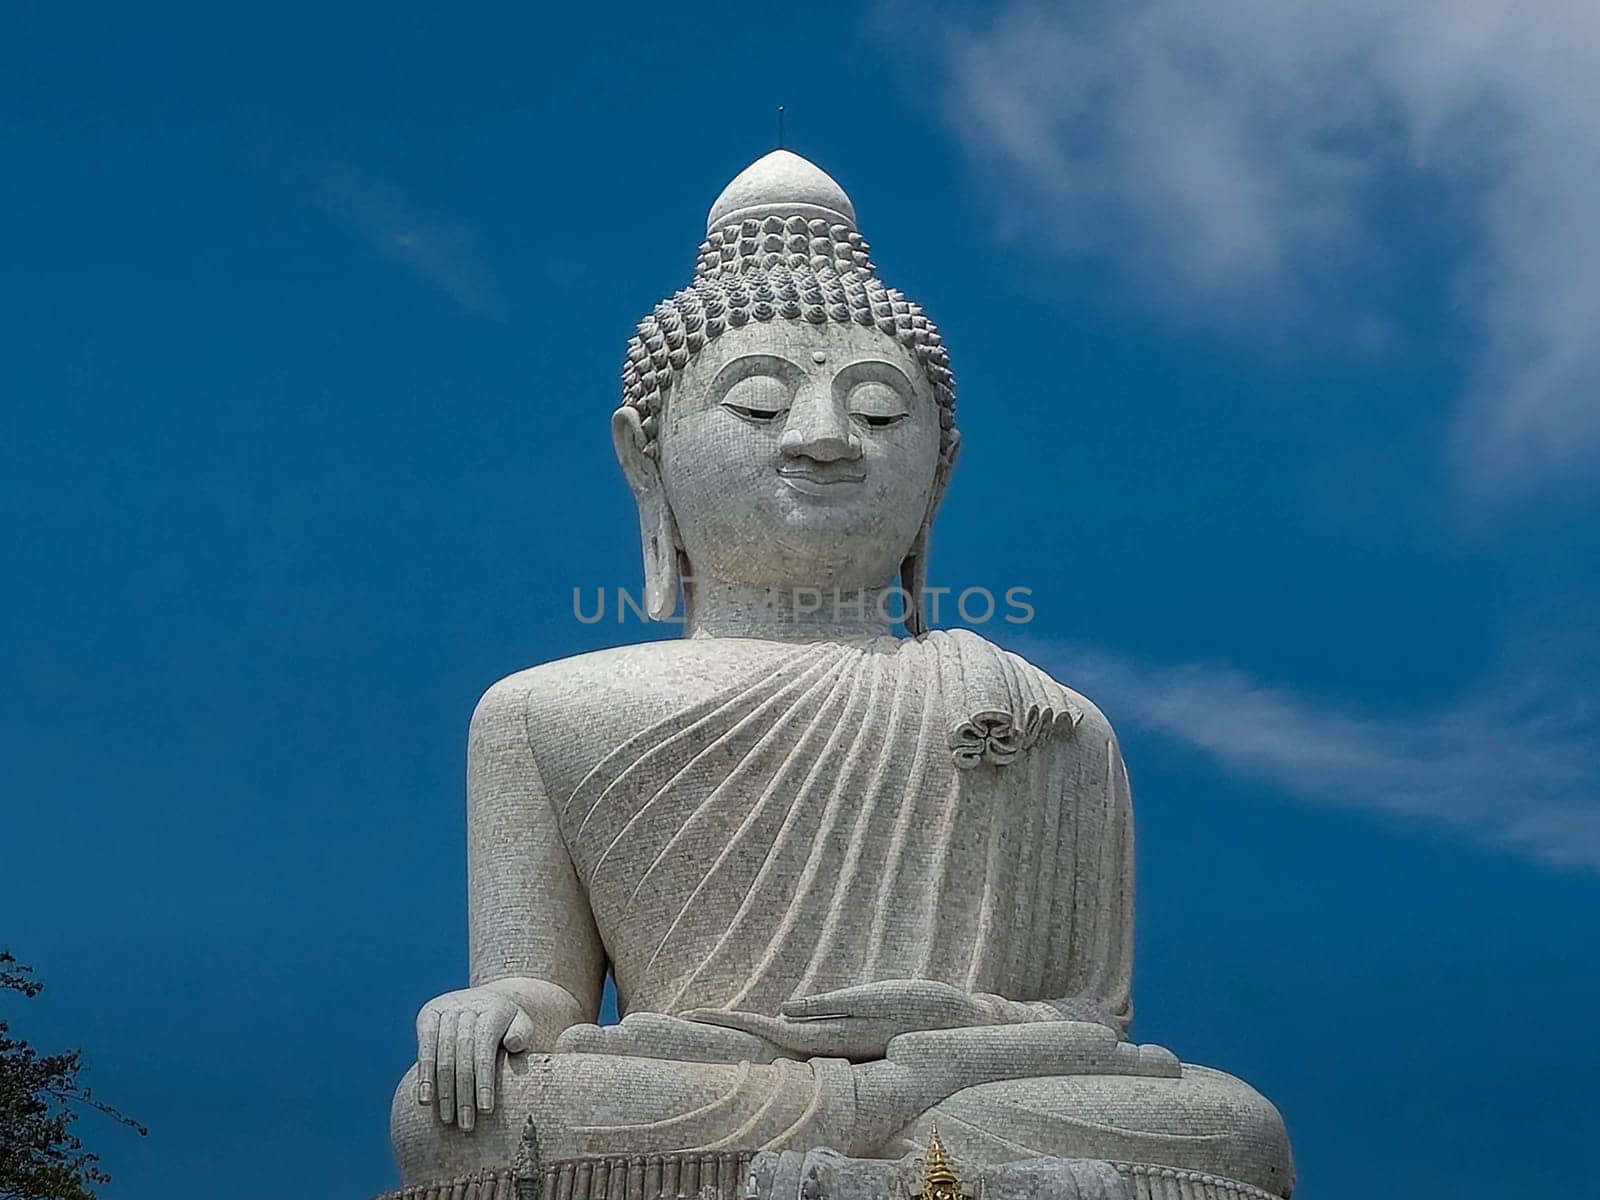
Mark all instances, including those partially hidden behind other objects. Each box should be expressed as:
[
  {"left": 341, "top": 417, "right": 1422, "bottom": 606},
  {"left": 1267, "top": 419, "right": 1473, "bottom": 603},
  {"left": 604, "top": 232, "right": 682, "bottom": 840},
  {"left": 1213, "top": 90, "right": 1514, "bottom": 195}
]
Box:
[{"left": 392, "top": 150, "right": 1294, "bottom": 1200}]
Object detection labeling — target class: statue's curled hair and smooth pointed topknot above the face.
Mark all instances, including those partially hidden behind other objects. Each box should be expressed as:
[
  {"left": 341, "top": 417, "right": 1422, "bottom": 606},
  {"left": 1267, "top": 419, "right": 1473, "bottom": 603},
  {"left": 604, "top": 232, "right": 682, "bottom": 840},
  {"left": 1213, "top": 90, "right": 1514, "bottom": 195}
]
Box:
[{"left": 622, "top": 150, "right": 960, "bottom": 472}]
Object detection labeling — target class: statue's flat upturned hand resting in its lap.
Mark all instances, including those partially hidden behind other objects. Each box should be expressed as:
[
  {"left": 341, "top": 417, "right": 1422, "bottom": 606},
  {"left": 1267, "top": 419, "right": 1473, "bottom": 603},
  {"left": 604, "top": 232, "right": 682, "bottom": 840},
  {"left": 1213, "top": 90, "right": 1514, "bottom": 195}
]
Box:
[{"left": 686, "top": 979, "right": 1011, "bottom": 1059}]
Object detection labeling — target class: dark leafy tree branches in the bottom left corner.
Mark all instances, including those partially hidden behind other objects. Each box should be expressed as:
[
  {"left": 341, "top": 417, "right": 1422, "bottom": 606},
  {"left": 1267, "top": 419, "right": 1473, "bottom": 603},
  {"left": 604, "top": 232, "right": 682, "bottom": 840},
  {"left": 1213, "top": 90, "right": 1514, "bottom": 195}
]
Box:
[{"left": 0, "top": 950, "right": 146, "bottom": 1200}]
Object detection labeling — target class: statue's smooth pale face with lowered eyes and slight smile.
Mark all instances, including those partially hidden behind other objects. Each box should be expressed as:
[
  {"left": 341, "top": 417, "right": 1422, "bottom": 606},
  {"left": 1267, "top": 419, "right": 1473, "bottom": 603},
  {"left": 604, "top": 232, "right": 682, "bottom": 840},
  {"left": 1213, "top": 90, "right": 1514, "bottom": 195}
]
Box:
[{"left": 658, "top": 320, "right": 939, "bottom": 590}]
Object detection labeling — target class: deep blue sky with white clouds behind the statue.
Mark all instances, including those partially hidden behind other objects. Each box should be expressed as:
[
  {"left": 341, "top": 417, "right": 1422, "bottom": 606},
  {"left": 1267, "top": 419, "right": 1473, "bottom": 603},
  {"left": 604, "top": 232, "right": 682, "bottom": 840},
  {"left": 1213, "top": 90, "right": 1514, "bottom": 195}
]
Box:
[{"left": 0, "top": 0, "right": 1600, "bottom": 1200}]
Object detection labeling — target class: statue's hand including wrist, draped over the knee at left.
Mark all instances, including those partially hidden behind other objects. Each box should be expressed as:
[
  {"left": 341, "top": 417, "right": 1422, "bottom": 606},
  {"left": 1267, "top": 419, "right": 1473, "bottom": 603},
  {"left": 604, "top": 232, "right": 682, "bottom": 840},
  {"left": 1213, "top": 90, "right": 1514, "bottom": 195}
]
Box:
[{"left": 416, "top": 979, "right": 582, "bottom": 1133}]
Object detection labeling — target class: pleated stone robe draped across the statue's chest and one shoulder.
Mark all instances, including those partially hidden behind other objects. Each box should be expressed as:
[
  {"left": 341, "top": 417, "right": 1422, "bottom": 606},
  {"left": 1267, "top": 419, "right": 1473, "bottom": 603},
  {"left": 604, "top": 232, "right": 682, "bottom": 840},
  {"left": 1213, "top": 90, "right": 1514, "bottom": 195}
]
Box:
[{"left": 560, "top": 630, "right": 1133, "bottom": 1027}]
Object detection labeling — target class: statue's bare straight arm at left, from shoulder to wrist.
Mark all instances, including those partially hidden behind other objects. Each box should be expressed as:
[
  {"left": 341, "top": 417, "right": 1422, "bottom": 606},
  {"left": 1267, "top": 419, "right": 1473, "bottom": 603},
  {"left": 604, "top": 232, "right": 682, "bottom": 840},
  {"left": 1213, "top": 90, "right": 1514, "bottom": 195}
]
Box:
[{"left": 467, "top": 677, "right": 605, "bottom": 1048}]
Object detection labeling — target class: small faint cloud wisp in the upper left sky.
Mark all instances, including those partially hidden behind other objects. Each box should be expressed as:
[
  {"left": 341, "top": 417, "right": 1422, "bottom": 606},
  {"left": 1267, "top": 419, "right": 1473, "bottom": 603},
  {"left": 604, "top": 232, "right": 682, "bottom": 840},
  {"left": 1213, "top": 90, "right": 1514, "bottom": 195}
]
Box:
[{"left": 315, "top": 163, "right": 504, "bottom": 317}]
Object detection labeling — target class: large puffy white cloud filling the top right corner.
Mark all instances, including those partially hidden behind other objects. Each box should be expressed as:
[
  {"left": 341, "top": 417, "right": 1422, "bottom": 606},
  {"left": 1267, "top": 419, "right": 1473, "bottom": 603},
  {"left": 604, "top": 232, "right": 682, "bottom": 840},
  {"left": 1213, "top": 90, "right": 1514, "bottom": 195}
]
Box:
[{"left": 942, "top": 0, "right": 1600, "bottom": 494}]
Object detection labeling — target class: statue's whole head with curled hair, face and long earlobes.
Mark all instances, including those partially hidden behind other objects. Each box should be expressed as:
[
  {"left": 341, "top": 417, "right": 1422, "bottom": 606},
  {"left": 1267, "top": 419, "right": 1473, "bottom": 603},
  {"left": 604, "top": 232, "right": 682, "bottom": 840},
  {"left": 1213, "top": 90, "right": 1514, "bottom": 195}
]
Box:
[{"left": 611, "top": 150, "right": 960, "bottom": 634}]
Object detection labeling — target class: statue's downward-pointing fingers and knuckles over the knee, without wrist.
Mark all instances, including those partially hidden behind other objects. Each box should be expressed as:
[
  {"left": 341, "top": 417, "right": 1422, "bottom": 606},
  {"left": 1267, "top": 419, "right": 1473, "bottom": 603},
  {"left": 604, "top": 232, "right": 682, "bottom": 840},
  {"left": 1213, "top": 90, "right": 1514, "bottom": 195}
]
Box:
[{"left": 416, "top": 987, "right": 533, "bottom": 1133}]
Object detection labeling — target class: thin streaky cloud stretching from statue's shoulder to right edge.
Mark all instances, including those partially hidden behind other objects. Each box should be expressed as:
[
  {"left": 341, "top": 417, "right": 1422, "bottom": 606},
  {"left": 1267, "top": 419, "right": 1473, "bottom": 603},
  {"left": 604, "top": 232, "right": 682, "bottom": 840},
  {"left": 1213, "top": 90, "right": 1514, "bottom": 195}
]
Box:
[{"left": 1034, "top": 643, "right": 1600, "bottom": 870}]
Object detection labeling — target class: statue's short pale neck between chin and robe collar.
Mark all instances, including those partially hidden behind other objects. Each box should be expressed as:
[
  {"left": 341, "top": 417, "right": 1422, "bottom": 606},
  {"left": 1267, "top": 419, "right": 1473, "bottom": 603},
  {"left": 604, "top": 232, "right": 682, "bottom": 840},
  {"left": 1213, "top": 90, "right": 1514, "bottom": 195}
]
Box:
[{"left": 683, "top": 579, "right": 899, "bottom": 642}]
